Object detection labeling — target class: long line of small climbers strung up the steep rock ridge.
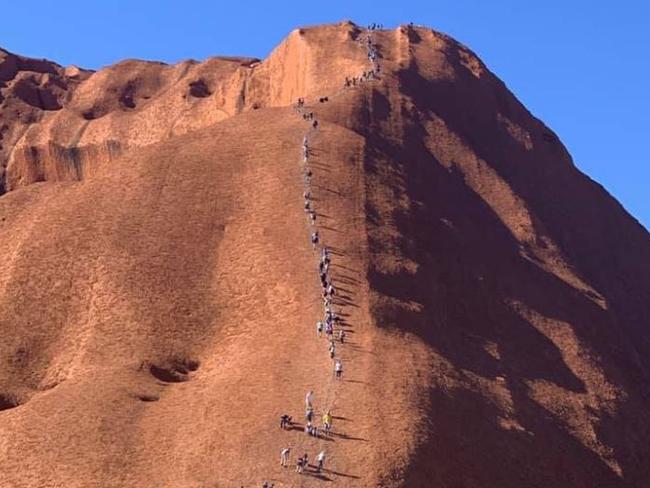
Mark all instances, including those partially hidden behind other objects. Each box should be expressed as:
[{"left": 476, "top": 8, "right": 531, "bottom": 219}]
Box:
[{"left": 263, "top": 24, "right": 381, "bottom": 488}]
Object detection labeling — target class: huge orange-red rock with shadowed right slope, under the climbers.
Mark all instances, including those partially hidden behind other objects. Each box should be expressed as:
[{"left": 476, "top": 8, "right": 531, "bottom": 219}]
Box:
[{"left": 0, "top": 22, "right": 650, "bottom": 488}]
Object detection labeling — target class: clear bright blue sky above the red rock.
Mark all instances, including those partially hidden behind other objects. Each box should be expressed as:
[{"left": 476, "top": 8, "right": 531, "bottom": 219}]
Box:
[{"left": 0, "top": 0, "right": 650, "bottom": 228}]
